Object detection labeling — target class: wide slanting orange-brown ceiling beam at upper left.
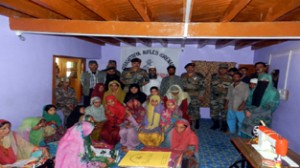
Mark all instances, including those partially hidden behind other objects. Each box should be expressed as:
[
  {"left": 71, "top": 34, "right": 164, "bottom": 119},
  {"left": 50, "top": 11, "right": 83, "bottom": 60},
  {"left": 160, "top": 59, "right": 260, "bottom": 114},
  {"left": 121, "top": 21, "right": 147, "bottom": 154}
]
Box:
[{"left": 31, "top": 0, "right": 102, "bottom": 20}]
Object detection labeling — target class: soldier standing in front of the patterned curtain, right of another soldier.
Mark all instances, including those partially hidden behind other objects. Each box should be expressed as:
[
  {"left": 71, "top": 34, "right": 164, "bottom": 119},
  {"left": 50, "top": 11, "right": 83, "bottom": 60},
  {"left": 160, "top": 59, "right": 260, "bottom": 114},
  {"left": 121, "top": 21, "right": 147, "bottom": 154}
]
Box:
[{"left": 210, "top": 63, "right": 232, "bottom": 132}]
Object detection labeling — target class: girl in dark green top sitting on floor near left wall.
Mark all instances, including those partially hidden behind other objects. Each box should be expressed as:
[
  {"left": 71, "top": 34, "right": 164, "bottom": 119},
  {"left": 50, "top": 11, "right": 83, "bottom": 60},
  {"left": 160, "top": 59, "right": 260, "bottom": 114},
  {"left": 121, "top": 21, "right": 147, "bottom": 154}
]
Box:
[{"left": 43, "top": 104, "right": 65, "bottom": 143}]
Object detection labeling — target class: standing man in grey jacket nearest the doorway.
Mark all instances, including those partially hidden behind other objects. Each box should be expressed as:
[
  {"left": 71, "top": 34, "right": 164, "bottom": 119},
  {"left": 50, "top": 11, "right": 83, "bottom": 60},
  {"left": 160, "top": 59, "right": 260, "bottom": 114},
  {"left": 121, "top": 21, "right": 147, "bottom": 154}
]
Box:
[{"left": 80, "top": 60, "right": 106, "bottom": 107}]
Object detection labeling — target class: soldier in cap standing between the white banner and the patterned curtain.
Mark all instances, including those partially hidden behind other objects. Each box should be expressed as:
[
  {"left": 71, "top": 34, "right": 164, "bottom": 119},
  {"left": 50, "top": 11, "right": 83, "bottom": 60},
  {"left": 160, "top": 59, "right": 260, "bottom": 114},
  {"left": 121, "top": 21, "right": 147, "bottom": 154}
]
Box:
[{"left": 181, "top": 63, "right": 205, "bottom": 129}]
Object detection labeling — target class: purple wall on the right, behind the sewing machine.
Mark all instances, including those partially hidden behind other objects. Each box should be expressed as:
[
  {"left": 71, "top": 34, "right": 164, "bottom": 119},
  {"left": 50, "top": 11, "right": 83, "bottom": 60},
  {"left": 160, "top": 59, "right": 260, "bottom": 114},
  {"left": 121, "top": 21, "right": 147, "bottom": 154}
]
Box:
[{"left": 254, "top": 41, "right": 300, "bottom": 154}]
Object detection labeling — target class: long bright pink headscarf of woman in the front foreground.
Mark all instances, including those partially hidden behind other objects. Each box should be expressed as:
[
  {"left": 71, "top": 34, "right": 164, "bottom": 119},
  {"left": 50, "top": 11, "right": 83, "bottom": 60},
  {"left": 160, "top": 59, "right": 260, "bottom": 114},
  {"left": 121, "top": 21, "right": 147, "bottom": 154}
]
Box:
[{"left": 55, "top": 121, "right": 94, "bottom": 168}]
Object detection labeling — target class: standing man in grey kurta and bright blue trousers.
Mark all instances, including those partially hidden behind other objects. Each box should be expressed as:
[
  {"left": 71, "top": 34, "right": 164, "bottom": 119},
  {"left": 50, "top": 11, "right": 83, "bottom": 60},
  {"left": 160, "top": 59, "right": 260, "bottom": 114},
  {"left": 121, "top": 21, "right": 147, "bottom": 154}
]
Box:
[{"left": 225, "top": 72, "right": 250, "bottom": 135}]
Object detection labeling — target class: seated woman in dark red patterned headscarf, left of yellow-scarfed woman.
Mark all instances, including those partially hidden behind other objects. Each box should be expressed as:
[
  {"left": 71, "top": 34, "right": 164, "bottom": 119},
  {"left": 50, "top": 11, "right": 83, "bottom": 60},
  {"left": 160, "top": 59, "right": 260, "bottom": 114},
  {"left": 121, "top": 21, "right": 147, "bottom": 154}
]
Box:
[{"left": 120, "top": 99, "right": 146, "bottom": 150}]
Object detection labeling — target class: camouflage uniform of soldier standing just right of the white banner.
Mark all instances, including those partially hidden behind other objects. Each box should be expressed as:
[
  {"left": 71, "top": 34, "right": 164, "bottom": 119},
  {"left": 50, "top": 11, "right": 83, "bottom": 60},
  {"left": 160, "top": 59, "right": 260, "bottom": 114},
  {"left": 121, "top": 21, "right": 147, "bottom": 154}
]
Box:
[{"left": 181, "top": 73, "right": 205, "bottom": 121}]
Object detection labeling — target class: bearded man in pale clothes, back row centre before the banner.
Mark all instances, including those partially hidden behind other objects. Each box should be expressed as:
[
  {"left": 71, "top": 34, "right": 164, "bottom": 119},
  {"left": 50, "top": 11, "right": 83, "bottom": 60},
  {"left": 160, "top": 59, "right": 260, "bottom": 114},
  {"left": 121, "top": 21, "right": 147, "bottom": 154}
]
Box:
[{"left": 142, "top": 66, "right": 162, "bottom": 96}]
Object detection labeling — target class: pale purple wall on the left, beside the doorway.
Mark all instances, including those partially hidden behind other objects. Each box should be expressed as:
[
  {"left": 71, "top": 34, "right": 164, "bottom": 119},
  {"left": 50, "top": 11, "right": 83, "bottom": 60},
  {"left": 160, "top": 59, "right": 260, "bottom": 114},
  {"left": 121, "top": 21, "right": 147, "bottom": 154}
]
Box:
[{"left": 0, "top": 16, "right": 101, "bottom": 129}]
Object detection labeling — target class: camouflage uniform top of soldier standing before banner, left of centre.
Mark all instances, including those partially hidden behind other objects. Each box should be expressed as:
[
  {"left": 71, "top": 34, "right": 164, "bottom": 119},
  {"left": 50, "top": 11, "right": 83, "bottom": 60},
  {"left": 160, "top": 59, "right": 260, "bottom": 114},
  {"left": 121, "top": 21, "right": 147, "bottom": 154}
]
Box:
[{"left": 121, "top": 68, "right": 149, "bottom": 92}]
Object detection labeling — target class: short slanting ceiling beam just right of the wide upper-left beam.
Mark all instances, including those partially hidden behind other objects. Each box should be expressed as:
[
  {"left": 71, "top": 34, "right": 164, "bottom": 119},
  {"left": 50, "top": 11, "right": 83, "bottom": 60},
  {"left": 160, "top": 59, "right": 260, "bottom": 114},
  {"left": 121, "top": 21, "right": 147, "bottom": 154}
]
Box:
[{"left": 77, "top": 0, "right": 117, "bottom": 20}]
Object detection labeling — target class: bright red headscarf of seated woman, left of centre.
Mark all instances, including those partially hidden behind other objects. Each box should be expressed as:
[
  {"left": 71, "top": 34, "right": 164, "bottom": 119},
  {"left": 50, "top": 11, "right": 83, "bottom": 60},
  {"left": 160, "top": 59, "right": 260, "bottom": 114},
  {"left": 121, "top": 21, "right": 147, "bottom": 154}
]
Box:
[{"left": 105, "top": 95, "right": 125, "bottom": 124}]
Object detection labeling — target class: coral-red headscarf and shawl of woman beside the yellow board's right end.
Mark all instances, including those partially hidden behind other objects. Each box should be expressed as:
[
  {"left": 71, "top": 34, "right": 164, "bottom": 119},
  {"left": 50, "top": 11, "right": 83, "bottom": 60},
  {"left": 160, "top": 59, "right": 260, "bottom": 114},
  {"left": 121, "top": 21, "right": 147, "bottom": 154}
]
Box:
[{"left": 171, "top": 119, "right": 199, "bottom": 153}]
